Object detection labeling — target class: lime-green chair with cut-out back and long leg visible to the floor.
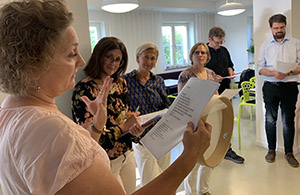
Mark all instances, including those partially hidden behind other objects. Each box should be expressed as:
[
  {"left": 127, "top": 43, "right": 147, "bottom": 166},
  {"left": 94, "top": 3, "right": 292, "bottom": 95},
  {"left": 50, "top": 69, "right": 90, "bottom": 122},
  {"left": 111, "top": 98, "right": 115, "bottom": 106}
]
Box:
[{"left": 234, "top": 81, "right": 255, "bottom": 149}]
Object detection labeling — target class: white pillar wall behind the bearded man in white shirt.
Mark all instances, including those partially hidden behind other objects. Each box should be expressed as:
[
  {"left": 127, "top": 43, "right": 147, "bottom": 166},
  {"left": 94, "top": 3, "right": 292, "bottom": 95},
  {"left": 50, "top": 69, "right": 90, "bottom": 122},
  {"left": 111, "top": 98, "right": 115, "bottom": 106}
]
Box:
[{"left": 253, "top": 0, "right": 300, "bottom": 151}]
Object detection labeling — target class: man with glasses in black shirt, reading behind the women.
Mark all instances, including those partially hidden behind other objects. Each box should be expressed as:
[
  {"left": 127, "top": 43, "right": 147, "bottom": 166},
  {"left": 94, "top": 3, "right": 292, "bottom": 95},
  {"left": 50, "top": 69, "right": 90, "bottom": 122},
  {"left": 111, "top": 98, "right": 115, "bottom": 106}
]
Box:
[{"left": 205, "top": 27, "right": 245, "bottom": 164}]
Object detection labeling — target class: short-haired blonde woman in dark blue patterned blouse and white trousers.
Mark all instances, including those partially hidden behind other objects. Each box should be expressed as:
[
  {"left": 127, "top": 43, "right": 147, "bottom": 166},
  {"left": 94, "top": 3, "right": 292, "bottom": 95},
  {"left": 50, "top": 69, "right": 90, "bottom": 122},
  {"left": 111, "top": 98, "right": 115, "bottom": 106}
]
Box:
[{"left": 124, "top": 42, "right": 170, "bottom": 186}]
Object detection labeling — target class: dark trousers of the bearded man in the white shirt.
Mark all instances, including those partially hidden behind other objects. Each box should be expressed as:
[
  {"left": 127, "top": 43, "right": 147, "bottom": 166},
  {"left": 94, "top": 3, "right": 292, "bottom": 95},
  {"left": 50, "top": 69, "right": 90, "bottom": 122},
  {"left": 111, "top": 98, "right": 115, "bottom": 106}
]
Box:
[{"left": 263, "top": 81, "right": 298, "bottom": 153}]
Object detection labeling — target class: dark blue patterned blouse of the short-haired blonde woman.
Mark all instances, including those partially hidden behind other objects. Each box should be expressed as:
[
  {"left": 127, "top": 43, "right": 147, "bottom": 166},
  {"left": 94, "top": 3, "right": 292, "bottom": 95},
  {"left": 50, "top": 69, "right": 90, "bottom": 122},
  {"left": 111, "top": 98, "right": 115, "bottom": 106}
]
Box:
[{"left": 124, "top": 70, "right": 170, "bottom": 115}]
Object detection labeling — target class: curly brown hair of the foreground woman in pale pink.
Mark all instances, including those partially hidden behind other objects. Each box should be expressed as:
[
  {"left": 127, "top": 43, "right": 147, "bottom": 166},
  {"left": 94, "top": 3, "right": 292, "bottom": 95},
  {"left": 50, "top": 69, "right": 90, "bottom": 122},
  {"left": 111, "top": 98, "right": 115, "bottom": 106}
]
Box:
[{"left": 0, "top": 0, "right": 73, "bottom": 96}]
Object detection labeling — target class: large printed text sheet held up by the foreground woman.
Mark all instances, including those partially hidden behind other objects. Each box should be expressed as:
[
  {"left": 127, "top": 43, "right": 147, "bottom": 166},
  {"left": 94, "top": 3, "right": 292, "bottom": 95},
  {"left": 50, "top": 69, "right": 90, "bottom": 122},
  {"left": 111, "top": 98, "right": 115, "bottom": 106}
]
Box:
[{"left": 141, "top": 78, "right": 219, "bottom": 159}]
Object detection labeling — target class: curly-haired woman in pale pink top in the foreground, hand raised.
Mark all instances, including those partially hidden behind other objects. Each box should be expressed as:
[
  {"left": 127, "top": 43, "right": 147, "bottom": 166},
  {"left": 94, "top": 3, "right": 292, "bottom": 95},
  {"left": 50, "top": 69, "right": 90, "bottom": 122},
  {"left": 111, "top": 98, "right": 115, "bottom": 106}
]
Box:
[{"left": 0, "top": 0, "right": 211, "bottom": 195}]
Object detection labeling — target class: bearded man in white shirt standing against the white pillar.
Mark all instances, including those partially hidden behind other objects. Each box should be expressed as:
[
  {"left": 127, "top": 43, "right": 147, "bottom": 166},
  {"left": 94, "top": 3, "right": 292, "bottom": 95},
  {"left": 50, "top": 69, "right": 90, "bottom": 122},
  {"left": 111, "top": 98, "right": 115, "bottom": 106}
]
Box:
[{"left": 257, "top": 14, "right": 300, "bottom": 167}]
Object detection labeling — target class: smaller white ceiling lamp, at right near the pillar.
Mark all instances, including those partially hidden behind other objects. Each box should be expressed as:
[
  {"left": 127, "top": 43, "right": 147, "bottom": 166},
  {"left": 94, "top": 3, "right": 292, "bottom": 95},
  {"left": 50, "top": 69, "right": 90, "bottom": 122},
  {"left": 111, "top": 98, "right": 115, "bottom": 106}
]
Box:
[{"left": 217, "top": 0, "right": 246, "bottom": 16}]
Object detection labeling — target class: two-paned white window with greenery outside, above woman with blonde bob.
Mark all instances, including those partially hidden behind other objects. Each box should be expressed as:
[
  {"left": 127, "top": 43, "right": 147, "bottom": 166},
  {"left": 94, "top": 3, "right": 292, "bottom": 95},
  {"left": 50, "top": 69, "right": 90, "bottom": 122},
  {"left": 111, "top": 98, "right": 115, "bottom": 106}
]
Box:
[{"left": 162, "top": 23, "right": 189, "bottom": 70}]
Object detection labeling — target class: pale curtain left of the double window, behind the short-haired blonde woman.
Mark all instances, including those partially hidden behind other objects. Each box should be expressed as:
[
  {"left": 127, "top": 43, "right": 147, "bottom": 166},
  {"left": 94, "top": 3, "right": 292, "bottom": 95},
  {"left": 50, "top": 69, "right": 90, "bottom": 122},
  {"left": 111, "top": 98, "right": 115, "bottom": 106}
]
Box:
[{"left": 104, "top": 11, "right": 163, "bottom": 72}]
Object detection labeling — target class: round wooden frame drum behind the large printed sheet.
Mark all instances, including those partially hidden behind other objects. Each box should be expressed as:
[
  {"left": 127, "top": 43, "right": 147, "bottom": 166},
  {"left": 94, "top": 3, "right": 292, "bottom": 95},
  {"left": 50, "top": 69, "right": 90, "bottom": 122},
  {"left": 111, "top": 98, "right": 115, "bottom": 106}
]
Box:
[{"left": 198, "top": 95, "right": 234, "bottom": 167}]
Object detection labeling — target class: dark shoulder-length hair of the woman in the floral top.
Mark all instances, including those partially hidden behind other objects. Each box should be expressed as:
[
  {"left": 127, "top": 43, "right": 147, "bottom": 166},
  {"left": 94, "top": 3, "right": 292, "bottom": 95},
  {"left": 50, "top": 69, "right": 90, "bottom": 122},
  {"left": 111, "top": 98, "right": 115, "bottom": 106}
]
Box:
[{"left": 83, "top": 37, "right": 128, "bottom": 81}]
